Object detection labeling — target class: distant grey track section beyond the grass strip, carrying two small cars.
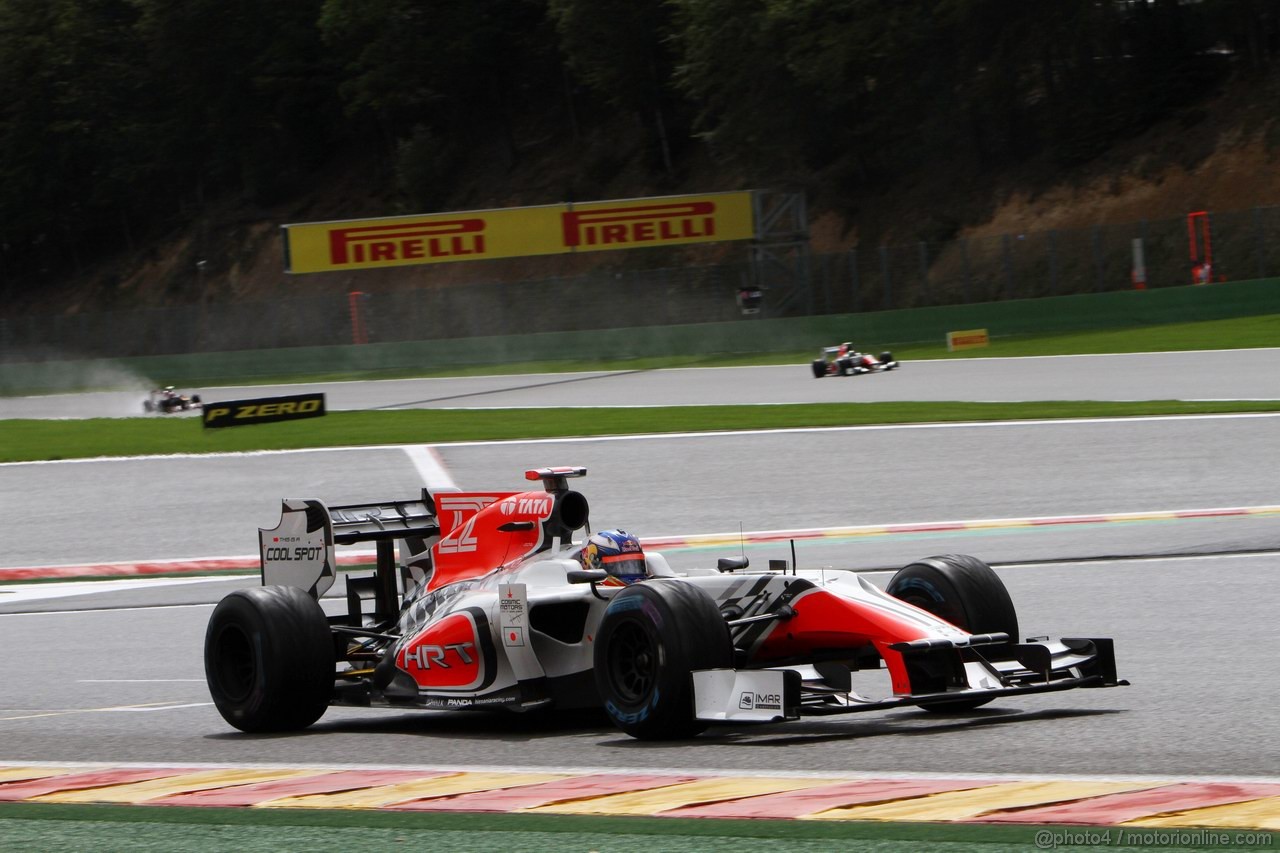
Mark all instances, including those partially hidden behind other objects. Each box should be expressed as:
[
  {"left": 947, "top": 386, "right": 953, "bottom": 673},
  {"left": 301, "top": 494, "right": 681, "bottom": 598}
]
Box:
[{"left": 0, "top": 348, "right": 1280, "bottom": 419}]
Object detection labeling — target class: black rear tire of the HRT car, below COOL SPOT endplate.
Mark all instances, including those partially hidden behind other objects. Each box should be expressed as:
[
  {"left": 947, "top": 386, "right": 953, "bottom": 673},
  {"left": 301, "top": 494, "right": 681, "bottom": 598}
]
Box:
[{"left": 205, "top": 587, "right": 334, "bottom": 733}]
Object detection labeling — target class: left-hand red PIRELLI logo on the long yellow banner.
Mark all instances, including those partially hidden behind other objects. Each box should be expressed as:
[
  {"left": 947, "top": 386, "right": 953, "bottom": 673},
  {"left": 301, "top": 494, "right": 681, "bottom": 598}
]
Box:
[{"left": 329, "top": 218, "right": 485, "bottom": 266}]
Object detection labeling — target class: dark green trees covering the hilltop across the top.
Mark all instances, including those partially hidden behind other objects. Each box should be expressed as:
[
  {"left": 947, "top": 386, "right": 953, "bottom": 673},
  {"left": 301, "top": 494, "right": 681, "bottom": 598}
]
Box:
[{"left": 0, "top": 0, "right": 1280, "bottom": 298}]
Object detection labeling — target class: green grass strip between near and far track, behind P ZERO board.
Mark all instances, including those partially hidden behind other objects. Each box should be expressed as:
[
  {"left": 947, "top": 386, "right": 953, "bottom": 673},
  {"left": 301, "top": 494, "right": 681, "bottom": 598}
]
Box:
[{"left": 0, "top": 400, "right": 1280, "bottom": 462}]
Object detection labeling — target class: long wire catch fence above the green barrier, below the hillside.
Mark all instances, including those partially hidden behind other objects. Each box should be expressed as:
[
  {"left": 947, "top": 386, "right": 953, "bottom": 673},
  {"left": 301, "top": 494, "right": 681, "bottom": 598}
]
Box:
[{"left": 0, "top": 207, "right": 1280, "bottom": 361}]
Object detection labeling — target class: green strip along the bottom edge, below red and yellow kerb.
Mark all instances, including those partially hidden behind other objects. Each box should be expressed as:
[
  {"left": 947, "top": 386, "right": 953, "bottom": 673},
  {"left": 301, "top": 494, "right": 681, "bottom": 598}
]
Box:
[{"left": 0, "top": 803, "right": 1276, "bottom": 853}]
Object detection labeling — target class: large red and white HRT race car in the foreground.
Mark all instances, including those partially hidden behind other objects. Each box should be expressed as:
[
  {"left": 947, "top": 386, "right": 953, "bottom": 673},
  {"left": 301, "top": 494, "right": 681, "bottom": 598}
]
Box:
[{"left": 205, "top": 467, "right": 1126, "bottom": 739}]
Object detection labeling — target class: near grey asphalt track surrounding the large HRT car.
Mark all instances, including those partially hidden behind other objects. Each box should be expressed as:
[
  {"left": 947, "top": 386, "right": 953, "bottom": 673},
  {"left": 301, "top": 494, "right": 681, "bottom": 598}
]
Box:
[{"left": 0, "top": 353, "right": 1280, "bottom": 777}]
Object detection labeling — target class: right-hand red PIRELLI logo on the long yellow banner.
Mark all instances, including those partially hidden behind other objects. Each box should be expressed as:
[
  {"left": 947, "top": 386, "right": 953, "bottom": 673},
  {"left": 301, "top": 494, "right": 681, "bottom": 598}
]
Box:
[{"left": 561, "top": 201, "right": 716, "bottom": 248}]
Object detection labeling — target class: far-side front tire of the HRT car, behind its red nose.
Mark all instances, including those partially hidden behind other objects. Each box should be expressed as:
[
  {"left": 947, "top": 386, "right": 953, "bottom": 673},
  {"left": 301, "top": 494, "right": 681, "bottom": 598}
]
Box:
[{"left": 886, "top": 555, "right": 1018, "bottom": 713}]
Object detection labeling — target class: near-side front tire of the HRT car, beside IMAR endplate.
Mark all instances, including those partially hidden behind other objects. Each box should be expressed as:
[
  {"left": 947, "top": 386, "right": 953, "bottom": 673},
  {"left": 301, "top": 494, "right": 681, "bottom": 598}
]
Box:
[{"left": 595, "top": 579, "right": 733, "bottom": 740}]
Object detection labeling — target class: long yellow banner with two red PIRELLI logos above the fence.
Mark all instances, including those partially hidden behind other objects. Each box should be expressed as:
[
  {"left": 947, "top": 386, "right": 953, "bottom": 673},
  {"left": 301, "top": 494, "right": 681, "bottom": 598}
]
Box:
[{"left": 283, "top": 191, "right": 755, "bottom": 273}]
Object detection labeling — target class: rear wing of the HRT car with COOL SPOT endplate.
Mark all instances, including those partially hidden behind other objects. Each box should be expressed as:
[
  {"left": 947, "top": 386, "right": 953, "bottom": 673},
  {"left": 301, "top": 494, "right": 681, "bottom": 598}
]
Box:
[{"left": 257, "top": 489, "right": 440, "bottom": 598}]
